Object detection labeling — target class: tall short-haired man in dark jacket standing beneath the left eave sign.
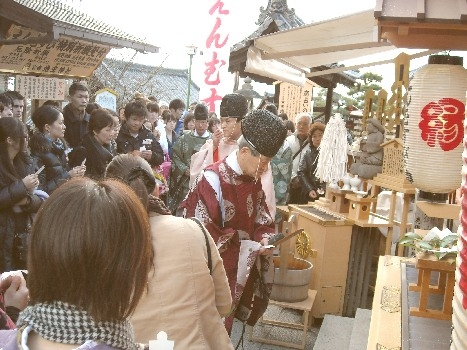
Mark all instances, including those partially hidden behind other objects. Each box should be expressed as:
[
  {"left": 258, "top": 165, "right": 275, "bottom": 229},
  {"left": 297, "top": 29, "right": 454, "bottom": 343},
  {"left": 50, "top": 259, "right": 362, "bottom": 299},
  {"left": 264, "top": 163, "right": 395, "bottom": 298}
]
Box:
[{"left": 63, "top": 82, "right": 89, "bottom": 148}]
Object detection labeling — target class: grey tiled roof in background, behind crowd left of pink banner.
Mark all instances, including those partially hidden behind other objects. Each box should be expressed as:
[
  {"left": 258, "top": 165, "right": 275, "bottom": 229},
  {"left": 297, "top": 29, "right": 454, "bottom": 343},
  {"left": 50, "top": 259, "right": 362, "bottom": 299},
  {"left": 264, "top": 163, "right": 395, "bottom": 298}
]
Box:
[{"left": 94, "top": 58, "right": 200, "bottom": 102}]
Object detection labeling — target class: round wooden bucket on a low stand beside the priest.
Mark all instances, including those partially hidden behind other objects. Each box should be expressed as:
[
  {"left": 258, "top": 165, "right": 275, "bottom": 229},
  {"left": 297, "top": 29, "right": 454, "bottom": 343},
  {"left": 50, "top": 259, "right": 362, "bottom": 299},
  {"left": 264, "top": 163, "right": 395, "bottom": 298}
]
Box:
[{"left": 271, "top": 257, "right": 313, "bottom": 303}]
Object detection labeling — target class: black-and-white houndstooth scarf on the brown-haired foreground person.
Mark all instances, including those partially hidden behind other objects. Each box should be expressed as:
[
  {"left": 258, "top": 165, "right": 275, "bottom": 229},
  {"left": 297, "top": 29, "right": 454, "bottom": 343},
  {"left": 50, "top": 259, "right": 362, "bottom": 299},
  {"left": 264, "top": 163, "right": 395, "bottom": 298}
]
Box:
[{"left": 17, "top": 301, "right": 140, "bottom": 350}]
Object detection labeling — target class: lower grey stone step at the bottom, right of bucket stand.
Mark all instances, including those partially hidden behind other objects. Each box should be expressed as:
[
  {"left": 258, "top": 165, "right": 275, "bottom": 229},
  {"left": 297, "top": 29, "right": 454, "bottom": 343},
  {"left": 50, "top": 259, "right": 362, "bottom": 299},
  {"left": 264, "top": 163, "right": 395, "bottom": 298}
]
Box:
[{"left": 313, "top": 315, "right": 355, "bottom": 350}]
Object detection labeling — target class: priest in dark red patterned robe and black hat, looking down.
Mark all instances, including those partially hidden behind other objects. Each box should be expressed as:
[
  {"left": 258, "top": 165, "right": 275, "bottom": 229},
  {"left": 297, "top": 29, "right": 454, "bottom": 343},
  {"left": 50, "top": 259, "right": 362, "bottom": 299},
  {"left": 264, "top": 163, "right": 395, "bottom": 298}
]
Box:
[{"left": 178, "top": 110, "right": 287, "bottom": 334}]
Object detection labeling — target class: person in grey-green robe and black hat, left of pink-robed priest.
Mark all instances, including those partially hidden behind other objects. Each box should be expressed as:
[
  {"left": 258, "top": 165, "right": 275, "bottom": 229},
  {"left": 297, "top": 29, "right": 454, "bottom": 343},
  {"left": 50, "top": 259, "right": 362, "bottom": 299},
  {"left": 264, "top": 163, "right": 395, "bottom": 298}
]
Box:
[{"left": 167, "top": 103, "right": 212, "bottom": 213}]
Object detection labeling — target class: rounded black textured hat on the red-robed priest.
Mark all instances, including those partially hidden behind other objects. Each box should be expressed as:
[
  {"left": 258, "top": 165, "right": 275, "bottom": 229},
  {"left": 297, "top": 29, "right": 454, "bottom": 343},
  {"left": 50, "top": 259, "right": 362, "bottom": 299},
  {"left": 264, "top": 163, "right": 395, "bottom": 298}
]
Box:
[{"left": 242, "top": 109, "right": 287, "bottom": 158}]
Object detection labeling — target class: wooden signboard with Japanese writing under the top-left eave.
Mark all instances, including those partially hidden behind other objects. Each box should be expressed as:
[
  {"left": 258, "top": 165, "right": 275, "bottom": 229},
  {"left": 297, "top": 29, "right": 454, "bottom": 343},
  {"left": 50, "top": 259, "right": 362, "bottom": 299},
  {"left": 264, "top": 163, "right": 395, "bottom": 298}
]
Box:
[{"left": 0, "top": 26, "right": 110, "bottom": 77}]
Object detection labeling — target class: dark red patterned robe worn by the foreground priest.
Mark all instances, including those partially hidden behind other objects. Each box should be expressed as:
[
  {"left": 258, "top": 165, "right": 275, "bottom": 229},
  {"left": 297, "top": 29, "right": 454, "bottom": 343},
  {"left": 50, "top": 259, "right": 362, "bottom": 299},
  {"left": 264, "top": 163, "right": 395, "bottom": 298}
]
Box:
[{"left": 179, "top": 159, "right": 274, "bottom": 333}]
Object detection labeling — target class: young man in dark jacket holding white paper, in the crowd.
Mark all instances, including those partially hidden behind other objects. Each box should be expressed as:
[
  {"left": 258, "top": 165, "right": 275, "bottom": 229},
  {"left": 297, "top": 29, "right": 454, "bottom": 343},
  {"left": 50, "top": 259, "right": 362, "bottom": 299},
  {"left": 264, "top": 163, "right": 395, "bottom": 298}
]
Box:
[{"left": 116, "top": 102, "right": 164, "bottom": 167}]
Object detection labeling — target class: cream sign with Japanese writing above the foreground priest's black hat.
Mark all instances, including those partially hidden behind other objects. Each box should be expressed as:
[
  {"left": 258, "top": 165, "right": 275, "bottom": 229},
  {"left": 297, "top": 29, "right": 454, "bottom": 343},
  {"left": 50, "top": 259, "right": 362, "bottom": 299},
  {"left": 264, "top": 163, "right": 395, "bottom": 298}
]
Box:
[{"left": 278, "top": 80, "right": 313, "bottom": 121}]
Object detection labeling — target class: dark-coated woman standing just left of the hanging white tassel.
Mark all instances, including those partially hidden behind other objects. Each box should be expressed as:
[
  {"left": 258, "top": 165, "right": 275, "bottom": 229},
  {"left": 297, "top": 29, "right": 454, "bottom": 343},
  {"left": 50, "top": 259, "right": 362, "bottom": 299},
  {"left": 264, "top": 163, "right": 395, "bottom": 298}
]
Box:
[{"left": 297, "top": 123, "right": 325, "bottom": 204}]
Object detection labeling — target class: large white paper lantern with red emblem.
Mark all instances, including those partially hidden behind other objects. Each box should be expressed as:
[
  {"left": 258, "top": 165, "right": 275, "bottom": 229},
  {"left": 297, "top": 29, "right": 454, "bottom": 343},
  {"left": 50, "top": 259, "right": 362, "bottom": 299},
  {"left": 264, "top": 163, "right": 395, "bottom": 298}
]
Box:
[{"left": 404, "top": 55, "right": 467, "bottom": 200}]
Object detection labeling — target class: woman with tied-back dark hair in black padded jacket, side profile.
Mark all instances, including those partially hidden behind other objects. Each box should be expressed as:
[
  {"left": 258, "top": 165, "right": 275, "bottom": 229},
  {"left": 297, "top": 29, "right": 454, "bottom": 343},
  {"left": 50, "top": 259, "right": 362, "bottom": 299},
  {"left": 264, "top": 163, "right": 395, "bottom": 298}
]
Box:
[{"left": 29, "top": 106, "right": 86, "bottom": 194}]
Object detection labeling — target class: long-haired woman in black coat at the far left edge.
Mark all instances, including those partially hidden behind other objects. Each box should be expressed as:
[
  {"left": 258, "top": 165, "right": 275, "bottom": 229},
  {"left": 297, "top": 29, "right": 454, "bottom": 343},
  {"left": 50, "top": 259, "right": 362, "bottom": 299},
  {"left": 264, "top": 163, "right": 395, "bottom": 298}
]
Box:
[{"left": 0, "top": 118, "right": 44, "bottom": 272}]
